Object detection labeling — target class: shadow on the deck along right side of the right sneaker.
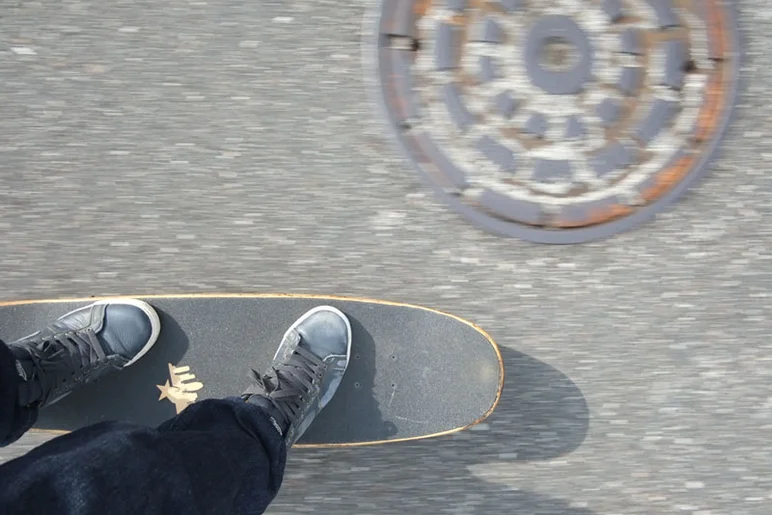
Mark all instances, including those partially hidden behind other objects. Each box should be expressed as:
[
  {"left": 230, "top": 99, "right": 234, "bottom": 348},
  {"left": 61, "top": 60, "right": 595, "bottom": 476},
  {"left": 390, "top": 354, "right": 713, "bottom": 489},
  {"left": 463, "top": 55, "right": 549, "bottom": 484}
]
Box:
[{"left": 298, "top": 313, "right": 397, "bottom": 444}]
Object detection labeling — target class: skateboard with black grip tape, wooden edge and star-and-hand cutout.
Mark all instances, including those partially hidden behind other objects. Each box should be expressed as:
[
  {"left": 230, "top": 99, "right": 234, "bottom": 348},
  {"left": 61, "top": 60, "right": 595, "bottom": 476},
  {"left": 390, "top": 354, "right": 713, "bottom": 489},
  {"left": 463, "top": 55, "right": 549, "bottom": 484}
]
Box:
[{"left": 0, "top": 294, "right": 504, "bottom": 447}]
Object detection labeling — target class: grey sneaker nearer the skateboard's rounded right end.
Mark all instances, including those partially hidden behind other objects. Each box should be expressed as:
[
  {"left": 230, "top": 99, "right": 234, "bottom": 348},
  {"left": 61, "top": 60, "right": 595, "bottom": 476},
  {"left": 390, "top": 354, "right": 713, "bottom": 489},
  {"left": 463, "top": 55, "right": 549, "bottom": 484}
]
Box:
[{"left": 241, "top": 306, "right": 351, "bottom": 446}]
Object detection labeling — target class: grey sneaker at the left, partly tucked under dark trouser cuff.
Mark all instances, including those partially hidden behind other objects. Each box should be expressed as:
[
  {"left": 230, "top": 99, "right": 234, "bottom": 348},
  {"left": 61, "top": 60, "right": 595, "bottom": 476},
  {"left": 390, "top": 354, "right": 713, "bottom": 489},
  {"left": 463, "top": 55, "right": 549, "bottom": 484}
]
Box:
[{"left": 9, "top": 299, "right": 161, "bottom": 408}]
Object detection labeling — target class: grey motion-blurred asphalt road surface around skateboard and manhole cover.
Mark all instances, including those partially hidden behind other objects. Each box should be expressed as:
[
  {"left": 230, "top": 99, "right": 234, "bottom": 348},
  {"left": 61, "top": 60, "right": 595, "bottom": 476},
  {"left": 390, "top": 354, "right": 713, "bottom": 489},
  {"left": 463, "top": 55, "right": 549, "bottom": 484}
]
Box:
[{"left": 0, "top": 0, "right": 772, "bottom": 515}]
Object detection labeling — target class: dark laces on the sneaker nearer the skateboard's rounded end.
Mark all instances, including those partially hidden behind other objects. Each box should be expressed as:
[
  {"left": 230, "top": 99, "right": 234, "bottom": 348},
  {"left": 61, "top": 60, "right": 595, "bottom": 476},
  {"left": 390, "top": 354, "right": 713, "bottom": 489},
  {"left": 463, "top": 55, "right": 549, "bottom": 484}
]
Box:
[{"left": 249, "top": 347, "right": 327, "bottom": 421}]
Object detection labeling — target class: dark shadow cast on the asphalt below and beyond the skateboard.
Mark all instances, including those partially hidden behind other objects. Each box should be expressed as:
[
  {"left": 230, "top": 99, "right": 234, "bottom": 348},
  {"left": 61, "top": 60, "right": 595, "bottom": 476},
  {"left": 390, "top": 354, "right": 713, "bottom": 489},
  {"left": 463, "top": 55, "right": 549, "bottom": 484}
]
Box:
[{"left": 266, "top": 348, "right": 593, "bottom": 515}]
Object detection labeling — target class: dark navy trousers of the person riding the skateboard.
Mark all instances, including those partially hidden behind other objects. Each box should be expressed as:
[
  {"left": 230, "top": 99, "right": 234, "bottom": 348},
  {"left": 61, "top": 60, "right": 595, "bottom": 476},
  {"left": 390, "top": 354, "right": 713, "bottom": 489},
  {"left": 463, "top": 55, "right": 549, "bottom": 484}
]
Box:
[{"left": 0, "top": 342, "right": 286, "bottom": 515}]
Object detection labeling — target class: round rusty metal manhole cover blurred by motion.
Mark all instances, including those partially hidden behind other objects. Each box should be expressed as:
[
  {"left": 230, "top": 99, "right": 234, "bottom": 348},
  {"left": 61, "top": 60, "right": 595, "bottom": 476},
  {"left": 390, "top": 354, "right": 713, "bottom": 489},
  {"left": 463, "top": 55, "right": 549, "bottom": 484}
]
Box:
[{"left": 377, "top": 0, "right": 739, "bottom": 243}]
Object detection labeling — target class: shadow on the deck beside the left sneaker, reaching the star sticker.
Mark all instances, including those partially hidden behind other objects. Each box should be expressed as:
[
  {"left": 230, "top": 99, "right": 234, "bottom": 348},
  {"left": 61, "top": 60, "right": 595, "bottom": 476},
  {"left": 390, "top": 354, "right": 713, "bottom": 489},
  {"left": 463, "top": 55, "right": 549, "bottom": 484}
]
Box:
[{"left": 35, "top": 306, "right": 189, "bottom": 430}]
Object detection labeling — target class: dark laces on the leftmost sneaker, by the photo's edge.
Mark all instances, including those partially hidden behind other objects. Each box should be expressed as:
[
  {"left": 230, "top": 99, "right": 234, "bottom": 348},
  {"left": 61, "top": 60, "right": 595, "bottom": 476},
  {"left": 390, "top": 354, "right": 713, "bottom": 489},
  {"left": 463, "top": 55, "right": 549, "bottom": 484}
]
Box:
[{"left": 25, "top": 329, "right": 106, "bottom": 403}]
